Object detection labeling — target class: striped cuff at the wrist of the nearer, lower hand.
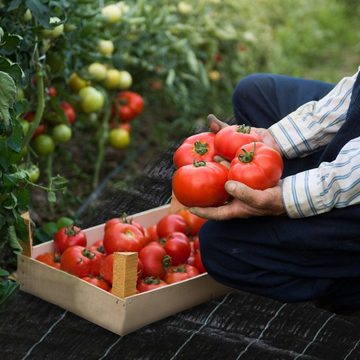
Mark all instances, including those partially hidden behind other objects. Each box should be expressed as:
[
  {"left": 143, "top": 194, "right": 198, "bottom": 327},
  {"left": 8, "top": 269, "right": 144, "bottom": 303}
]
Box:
[{"left": 281, "top": 168, "right": 330, "bottom": 218}]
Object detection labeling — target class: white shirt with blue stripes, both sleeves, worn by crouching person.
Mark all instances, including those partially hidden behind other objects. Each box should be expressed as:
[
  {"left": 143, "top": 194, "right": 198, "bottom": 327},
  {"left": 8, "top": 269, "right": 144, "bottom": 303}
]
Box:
[{"left": 269, "top": 68, "right": 360, "bottom": 218}]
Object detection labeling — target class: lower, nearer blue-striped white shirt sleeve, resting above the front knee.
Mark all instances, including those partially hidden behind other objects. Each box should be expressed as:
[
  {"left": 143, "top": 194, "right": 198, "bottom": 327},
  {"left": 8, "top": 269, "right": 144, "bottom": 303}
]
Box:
[{"left": 281, "top": 137, "right": 360, "bottom": 218}]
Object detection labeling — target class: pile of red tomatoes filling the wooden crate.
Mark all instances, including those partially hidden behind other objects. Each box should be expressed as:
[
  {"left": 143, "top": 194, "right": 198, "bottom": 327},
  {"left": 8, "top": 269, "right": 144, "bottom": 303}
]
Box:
[{"left": 36, "top": 209, "right": 206, "bottom": 292}]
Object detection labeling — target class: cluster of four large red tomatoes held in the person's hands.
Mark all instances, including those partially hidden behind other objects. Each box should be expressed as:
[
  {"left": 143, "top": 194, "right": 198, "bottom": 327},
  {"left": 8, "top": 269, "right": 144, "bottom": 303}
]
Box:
[{"left": 173, "top": 125, "right": 283, "bottom": 207}]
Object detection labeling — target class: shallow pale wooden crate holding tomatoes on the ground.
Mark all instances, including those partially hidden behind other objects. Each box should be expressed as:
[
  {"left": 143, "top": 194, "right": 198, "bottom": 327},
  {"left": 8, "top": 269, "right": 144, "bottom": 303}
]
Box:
[{"left": 17, "top": 205, "right": 231, "bottom": 335}]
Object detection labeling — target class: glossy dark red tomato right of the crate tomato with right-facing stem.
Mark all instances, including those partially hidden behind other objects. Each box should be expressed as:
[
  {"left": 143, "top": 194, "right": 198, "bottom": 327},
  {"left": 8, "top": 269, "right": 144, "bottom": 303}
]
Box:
[{"left": 164, "top": 232, "right": 191, "bottom": 266}]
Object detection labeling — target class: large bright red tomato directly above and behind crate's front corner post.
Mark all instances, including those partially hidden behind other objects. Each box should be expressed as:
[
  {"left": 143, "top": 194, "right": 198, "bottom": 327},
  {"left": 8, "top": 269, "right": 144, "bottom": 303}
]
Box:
[{"left": 104, "top": 223, "right": 145, "bottom": 254}]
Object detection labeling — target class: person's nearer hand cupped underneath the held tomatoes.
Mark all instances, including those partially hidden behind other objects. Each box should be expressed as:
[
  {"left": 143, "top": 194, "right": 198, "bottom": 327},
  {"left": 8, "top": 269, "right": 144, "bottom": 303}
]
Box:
[{"left": 189, "top": 181, "right": 285, "bottom": 220}]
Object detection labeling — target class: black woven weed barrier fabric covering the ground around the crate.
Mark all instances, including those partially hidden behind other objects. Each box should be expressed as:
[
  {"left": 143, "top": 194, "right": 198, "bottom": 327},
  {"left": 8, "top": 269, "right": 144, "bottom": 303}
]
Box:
[{"left": 0, "top": 139, "right": 360, "bottom": 360}]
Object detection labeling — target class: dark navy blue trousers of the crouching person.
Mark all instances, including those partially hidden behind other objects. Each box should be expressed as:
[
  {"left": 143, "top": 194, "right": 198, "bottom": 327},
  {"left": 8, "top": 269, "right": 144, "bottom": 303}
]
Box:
[{"left": 200, "top": 74, "right": 360, "bottom": 307}]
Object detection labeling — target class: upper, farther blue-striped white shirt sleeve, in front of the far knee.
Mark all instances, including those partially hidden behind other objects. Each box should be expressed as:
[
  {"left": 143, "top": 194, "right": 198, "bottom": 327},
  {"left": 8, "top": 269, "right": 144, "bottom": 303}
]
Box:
[{"left": 268, "top": 72, "right": 358, "bottom": 159}]
